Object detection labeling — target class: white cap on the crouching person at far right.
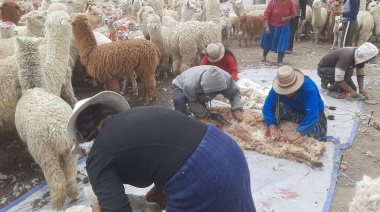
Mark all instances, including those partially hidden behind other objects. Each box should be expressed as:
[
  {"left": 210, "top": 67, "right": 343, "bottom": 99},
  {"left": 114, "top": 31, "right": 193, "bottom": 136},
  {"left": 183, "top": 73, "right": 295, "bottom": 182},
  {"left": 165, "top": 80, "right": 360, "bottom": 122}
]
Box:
[{"left": 355, "top": 42, "right": 379, "bottom": 65}]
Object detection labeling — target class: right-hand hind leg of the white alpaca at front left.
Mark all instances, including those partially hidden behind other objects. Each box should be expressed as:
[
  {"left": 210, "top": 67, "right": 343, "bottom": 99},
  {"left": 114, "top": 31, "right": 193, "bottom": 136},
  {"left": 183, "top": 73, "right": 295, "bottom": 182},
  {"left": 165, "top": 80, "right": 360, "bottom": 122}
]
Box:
[{"left": 61, "top": 153, "right": 79, "bottom": 199}]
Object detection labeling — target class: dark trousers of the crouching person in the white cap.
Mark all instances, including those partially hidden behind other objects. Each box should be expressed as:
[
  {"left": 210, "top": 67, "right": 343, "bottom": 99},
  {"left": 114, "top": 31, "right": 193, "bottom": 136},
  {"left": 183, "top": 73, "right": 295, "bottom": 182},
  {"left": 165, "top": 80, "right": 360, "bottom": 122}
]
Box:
[{"left": 317, "top": 67, "right": 357, "bottom": 92}]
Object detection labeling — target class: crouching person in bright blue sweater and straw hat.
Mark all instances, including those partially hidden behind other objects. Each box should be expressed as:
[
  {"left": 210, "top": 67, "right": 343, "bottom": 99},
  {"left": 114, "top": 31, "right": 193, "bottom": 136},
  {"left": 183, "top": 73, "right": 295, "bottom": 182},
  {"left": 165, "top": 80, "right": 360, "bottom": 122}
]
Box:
[{"left": 262, "top": 66, "right": 327, "bottom": 141}]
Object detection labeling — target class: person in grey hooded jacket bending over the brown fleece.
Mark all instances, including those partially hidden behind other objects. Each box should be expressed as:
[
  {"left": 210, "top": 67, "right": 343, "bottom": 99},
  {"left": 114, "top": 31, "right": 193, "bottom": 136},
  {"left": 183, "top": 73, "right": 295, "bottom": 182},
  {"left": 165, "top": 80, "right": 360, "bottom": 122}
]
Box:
[{"left": 172, "top": 65, "right": 243, "bottom": 121}]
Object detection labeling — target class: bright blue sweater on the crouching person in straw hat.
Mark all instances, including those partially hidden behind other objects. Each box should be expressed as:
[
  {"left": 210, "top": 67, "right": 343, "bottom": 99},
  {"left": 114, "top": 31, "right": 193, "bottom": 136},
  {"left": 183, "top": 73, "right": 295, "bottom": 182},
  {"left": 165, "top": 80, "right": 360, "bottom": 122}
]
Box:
[{"left": 263, "top": 77, "right": 324, "bottom": 136}]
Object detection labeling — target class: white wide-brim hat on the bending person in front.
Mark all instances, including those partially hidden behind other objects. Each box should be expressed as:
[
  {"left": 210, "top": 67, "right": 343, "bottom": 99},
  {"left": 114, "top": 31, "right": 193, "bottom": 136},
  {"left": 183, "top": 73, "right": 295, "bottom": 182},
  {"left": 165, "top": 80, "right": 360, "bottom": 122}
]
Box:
[{"left": 66, "top": 91, "right": 130, "bottom": 142}]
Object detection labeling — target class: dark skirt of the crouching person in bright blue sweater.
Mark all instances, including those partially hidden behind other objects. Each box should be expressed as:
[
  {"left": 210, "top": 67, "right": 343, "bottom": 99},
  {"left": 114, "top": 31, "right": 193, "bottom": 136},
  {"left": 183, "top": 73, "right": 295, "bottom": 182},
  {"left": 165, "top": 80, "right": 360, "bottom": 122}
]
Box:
[{"left": 280, "top": 102, "right": 327, "bottom": 141}]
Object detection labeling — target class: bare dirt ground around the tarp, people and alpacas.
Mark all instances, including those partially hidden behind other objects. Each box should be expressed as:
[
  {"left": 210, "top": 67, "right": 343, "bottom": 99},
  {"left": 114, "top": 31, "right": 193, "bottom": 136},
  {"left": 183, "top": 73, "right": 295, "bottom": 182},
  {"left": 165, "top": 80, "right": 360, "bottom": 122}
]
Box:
[{"left": 0, "top": 38, "right": 380, "bottom": 212}]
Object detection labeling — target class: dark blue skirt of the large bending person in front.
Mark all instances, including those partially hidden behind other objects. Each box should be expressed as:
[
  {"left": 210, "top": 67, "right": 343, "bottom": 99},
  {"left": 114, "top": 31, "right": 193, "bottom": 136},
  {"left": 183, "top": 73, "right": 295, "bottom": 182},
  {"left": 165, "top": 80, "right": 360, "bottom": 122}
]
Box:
[{"left": 163, "top": 125, "right": 256, "bottom": 212}]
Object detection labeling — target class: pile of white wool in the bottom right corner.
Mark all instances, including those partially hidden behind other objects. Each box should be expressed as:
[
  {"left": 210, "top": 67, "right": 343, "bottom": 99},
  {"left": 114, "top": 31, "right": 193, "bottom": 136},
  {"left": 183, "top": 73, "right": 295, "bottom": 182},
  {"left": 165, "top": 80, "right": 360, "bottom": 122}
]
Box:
[{"left": 348, "top": 175, "right": 380, "bottom": 212}]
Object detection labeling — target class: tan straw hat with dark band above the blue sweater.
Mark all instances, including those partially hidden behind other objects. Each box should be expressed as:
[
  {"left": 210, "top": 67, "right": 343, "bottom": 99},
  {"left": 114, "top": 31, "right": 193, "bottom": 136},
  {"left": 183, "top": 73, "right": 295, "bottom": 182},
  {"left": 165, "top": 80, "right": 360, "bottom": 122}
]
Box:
[{"left": 273, "top": 66, "right": 305, "bottom": 95}]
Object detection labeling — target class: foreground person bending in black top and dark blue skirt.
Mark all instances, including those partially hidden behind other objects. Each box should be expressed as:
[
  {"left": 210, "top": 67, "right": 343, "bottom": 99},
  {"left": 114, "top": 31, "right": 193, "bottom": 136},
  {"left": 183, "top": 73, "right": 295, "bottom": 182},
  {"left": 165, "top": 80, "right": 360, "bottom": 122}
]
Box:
[{"left": 67, "top": 91, "right": 256, "bottom": 212}]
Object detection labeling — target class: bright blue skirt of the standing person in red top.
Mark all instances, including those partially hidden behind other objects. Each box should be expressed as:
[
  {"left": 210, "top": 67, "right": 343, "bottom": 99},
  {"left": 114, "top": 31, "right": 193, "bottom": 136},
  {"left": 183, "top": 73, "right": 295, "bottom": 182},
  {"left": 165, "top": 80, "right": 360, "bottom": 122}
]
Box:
[{"left": 261, "top": 23, "right": 290, "bottom": 52}]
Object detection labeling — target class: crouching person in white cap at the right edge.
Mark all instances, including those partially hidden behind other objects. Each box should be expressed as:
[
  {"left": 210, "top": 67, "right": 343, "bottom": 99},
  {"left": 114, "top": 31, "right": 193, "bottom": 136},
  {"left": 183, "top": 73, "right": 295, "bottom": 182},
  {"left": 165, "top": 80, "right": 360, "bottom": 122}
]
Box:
[{"left": 317, "top": 42, "right": 379, "bottom": 98}]
